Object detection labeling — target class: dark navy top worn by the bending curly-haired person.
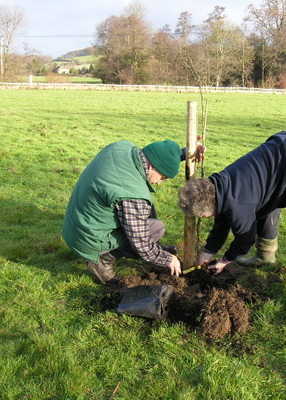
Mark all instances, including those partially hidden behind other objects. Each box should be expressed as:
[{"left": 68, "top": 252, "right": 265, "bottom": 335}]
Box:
[{"left": 205, "top": 131, "right": 286, "bottom": 261}]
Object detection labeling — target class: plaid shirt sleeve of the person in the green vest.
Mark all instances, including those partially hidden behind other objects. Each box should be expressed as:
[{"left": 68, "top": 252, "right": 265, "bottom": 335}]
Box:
[{"left": 116, "top": 199, "right": 172, "bottom": 267}]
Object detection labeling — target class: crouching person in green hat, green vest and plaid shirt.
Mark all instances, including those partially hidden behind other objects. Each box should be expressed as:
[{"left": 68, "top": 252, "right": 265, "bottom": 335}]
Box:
[{"left": 62, "top": 140, "right": 185, "bottom": 284}]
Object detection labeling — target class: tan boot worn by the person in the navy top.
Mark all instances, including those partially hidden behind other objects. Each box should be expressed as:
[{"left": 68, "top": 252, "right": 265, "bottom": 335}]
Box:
[{"left": 236, "top": 236, "right": 278, "bottom": 267}]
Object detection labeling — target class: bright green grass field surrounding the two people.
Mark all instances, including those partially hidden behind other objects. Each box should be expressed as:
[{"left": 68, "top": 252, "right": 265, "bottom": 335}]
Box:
[{"left": 0, "top": 90, "right": 286, "bottom": 400}]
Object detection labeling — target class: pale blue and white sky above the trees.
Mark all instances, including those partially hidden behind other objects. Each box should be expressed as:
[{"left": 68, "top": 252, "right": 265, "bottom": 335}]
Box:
[{"left": 9, "top": 0, "right": 262, "bottom": 58}]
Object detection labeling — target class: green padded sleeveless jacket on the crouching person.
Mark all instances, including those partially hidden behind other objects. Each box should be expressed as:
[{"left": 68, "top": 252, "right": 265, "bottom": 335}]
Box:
[{"left": 62, "top": 140, "right": 154, "bottom": 262}]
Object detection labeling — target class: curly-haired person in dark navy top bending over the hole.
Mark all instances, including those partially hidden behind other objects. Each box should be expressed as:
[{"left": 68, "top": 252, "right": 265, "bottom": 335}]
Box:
[{"left": 179, "top": 131, "right": 286, "bottom": 273}]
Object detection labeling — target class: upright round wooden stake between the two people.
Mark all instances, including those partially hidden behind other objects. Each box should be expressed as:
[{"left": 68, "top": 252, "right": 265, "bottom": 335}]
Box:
[{"left": 184, "top": 101, "right": 198, "bottom": 269}]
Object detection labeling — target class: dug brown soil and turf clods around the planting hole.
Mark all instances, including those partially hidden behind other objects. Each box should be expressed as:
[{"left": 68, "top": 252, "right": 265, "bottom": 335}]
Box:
[{"left": 107, "top": 264, "right": 272, "bottom": 341}]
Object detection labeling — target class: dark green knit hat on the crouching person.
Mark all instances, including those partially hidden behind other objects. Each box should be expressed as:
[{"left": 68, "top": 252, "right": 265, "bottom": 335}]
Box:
[{"left": 142, "top": 140, "right": 181, "bottom": 178}]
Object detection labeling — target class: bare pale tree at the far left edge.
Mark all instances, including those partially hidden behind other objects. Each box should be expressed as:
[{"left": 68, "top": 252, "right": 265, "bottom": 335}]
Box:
[{"left": 0, "top": 6, "right": 25, "bottom": 80}]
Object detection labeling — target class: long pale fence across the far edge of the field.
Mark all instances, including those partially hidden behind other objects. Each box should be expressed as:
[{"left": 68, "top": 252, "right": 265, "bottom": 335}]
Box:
[{"left": 0, "top": 82, "right": 286, "bottom": 95}]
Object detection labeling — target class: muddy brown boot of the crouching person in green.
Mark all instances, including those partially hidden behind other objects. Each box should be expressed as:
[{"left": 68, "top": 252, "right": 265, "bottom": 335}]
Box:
[{"left": 86, "top": 253, "right": 116, "bottom": 285}]
